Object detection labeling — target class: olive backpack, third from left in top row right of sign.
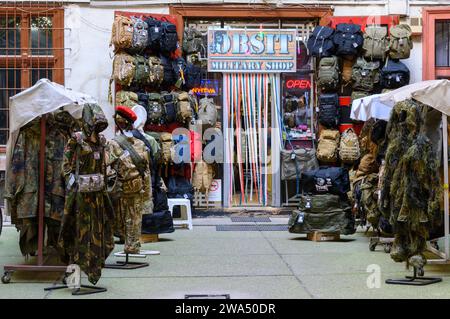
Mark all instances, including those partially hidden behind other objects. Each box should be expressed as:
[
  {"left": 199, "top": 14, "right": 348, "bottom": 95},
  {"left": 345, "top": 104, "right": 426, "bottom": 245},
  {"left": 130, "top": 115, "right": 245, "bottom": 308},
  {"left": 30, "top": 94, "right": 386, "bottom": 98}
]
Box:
[{"left": 363, "top": 25, "right": 389, "bottom": 61}]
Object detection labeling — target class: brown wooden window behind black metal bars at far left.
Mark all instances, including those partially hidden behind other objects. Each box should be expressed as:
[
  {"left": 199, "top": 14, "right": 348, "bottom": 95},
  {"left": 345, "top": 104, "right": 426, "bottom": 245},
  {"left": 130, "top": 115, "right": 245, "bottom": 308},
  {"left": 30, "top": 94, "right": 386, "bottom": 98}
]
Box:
[{"left": 0, "top": 1, "right": 64, "bottom": 146}]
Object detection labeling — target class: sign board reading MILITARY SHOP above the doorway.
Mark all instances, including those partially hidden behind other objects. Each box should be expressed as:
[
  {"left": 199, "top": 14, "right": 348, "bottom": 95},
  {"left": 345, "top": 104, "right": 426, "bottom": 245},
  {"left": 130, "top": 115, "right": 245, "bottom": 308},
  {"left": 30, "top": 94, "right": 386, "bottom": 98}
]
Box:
[{"left": 208, "top": 27, "right": 297, "bottom": 73}]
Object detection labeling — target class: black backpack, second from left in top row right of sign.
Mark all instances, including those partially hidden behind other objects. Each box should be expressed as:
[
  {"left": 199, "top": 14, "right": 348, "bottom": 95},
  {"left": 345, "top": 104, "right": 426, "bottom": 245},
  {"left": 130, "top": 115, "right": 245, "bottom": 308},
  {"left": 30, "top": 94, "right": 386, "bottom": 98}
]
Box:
[{"left": 333, "top": 23, "right": 364, "bottom": 56}]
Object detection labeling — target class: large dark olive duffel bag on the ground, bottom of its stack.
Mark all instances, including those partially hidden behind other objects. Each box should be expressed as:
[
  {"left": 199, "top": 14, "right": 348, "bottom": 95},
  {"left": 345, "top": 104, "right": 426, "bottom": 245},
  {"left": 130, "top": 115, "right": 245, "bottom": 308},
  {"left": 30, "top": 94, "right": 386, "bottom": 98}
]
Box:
[{"left": 288, "top": 194, "right": 356, "bottom": 235}]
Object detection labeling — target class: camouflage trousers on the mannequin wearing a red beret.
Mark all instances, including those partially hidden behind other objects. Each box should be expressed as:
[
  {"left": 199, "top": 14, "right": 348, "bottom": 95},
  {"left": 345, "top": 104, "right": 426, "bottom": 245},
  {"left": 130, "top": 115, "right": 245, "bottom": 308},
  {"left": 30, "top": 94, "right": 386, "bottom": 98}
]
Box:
[{"left": 114, "top": 194, "right": 143, "bottom": 254}]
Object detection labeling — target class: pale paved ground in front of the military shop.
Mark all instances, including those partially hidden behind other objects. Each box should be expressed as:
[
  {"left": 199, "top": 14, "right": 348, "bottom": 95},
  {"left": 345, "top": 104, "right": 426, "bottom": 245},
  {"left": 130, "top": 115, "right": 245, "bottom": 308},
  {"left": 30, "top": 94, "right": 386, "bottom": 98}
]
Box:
[{"left": 0, "top": 216, "right": 450, "bottom": 299}]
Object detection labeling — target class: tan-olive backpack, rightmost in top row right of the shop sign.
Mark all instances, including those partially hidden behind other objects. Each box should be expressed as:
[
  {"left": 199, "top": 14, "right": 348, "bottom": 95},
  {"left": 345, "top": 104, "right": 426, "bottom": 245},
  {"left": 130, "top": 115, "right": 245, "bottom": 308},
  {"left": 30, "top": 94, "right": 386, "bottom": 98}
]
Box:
[{"left": 389, "top": 24, "right": 413, "bottom": 59}]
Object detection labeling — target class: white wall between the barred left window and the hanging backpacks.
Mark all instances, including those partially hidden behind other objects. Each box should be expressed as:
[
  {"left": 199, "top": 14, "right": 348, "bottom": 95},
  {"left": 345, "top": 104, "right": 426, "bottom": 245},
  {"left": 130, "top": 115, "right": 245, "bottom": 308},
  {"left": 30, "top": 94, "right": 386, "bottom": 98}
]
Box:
[{"left": 64, "top": 4, "right": 169, "bottom": 138}]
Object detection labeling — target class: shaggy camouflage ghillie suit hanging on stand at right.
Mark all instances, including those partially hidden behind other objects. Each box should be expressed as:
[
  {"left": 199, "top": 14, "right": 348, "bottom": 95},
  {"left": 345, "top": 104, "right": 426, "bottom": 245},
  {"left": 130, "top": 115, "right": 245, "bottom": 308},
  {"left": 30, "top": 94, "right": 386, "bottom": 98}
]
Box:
[{"left": 380, "top": 100, "right": 442, "bottom": 267}]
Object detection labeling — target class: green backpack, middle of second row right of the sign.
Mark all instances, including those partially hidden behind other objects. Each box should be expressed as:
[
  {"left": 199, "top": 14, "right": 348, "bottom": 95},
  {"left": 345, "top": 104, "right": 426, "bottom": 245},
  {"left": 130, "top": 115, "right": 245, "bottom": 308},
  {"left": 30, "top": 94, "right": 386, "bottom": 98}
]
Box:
[{"left": 352, "top": 58, "right": 380, "bottom": 92}]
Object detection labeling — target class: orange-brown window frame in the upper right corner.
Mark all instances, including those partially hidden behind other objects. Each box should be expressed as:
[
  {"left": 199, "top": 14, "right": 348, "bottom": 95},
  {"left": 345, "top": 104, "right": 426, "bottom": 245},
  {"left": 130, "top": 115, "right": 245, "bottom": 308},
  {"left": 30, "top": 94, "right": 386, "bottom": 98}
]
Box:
[{"left": 422, "top": 6, "right": 450, "bottom": 81}]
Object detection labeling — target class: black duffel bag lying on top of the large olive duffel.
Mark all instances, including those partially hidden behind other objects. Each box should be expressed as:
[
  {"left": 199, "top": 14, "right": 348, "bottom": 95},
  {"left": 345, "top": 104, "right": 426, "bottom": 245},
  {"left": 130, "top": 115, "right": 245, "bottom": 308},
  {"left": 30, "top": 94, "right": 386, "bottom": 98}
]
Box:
[{"left": 300, "top": 166, "right": 350, "bottom": 196}]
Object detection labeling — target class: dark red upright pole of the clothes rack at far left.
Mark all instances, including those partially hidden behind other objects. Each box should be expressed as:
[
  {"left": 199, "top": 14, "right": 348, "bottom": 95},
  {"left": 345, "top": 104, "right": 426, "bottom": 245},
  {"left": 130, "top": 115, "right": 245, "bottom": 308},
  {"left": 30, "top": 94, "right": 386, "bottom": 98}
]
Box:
[{"left": 37, "top": 115, "right": 46, "bottom": 266}]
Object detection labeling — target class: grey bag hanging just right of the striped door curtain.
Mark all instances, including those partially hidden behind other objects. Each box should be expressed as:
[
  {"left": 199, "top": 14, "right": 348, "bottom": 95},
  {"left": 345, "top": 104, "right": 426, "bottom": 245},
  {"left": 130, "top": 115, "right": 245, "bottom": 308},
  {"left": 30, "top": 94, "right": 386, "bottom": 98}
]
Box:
[{"left": 281, "top": 148, "right": 319, "bottom": 180}]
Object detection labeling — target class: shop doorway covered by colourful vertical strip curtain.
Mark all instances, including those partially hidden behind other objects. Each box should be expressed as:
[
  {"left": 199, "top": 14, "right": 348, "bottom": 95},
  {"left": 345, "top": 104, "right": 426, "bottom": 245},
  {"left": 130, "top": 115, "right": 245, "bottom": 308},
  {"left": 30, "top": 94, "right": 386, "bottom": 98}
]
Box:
[{"left": 223, "top": 73, "right": 282, "bottom": 207}]
